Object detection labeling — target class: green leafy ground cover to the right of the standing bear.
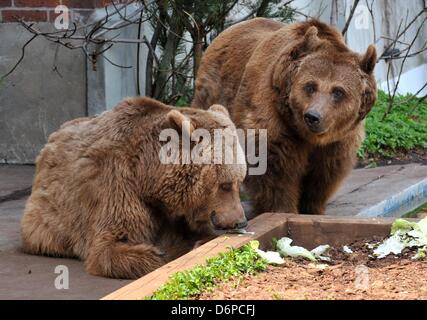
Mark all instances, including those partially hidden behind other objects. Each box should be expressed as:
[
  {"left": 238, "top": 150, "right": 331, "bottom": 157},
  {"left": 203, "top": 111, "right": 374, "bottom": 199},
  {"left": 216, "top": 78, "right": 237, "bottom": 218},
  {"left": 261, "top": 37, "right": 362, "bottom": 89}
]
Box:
[{"left": 358, "top": 91, "right": 427, "bottom": 158}]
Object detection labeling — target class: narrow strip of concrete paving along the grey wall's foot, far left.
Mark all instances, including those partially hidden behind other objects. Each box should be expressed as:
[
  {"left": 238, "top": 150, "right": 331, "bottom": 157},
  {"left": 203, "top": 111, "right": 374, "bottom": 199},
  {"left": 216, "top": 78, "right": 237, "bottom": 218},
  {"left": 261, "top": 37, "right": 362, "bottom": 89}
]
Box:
[{"left": 0, "top": 164, "right": 35, "bottom": 202}]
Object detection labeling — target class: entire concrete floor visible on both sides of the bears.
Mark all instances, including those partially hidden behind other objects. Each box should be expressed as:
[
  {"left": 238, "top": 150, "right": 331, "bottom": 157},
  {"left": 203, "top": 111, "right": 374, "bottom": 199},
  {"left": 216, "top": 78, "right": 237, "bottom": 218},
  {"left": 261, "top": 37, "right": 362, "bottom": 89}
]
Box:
[{"left": 0, "top": 164, "right": 427, "bottom": 299}]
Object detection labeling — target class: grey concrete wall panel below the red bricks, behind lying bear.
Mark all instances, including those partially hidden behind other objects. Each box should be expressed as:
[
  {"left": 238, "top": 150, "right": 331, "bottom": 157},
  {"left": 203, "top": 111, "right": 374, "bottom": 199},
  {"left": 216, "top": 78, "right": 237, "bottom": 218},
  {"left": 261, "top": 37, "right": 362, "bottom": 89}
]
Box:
[{"left": 0, "top": 23, "right": 87, "bottom": 163}]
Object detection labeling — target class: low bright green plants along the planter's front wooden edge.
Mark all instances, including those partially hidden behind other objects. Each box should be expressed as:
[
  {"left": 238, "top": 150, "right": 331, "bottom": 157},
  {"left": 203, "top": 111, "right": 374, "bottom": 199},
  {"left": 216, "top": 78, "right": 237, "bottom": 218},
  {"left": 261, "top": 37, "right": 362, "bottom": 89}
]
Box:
[{"left": 146, "top": 244, "right": 267, "bottom": 300}]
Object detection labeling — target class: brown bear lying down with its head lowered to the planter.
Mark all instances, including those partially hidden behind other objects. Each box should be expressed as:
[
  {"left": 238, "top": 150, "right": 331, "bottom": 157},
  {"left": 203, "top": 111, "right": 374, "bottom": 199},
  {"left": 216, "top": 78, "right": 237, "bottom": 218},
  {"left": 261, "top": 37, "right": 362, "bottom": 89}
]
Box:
[{"left": 22, "top": 98, "right": 246, "bottom": 278}]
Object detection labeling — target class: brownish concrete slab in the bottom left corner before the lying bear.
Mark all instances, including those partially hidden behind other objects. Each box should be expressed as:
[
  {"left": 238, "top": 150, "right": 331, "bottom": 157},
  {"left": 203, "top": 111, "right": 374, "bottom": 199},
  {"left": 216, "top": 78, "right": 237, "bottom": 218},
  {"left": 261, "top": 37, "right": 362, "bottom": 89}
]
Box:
[{"left": 0, "top": 199, "right": 130, "bottom": 300}]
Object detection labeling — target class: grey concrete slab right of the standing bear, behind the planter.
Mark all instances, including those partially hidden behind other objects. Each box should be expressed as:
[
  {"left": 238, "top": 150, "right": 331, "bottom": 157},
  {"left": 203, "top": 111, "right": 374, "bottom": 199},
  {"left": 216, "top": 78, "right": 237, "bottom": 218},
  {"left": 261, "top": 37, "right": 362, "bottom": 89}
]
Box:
[{"left": 326, "top": 164, "right": 427, "bottom": 216}]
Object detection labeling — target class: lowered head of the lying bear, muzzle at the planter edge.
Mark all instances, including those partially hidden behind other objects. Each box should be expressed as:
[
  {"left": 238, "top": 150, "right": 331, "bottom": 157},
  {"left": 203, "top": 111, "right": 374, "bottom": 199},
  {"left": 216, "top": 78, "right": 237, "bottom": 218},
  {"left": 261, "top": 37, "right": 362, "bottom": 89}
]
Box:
[{"left": 156, "top": 105, "right": 247, "bottom": 234}]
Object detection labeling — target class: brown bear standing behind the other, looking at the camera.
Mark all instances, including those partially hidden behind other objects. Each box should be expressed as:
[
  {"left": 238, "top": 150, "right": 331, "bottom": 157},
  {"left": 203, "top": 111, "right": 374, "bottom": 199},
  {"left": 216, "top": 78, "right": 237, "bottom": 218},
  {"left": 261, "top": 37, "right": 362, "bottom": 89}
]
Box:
[{"left": 193, "top": 18, "right": 376, "bottom": 214}]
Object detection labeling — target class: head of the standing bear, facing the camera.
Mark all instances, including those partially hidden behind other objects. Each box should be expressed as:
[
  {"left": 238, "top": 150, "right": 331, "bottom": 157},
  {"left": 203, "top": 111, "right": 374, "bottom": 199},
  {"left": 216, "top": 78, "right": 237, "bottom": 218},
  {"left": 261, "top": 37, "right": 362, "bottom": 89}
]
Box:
[{"left": 272, "top": 21, "right": 377, "bottom": 144}]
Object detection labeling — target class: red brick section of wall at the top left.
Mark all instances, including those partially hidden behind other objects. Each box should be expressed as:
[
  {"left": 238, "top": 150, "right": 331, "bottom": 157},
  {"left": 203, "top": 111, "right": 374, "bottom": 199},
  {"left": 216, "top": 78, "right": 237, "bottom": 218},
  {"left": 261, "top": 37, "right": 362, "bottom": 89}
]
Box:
[{"left": 0, "top": 0, "right": 120, "bottom": 22}]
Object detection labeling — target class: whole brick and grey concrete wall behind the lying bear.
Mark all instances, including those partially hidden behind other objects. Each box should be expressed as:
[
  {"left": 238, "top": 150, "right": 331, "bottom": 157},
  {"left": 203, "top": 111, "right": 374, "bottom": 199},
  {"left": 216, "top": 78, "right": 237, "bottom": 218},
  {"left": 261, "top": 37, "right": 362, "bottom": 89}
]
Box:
[{"left": 0, "top": 0, "right": 147, "bottom": 164}]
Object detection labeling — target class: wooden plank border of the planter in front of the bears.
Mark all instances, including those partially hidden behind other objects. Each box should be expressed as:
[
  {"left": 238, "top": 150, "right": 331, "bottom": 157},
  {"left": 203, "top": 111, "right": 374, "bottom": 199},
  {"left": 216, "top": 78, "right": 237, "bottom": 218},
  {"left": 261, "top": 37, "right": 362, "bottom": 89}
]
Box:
[{"left": 103, "top": 213, "right": 400, "bottom": 300}]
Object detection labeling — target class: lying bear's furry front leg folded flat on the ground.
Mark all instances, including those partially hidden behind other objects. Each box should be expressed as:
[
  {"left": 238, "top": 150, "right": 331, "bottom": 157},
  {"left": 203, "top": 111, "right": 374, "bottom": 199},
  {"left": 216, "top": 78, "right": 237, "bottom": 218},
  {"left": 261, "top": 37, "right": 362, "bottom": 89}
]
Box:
[{"left": 86, "top": 232, "right": 165, "bottom": 279}]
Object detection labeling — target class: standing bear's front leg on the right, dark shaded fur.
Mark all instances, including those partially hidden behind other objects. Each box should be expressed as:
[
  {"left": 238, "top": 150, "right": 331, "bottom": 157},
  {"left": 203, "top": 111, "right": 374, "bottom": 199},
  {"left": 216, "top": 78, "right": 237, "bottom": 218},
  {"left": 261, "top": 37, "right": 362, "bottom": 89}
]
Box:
[{"left": 298, "top": 142, "right": 357, "bottom": 214}]
